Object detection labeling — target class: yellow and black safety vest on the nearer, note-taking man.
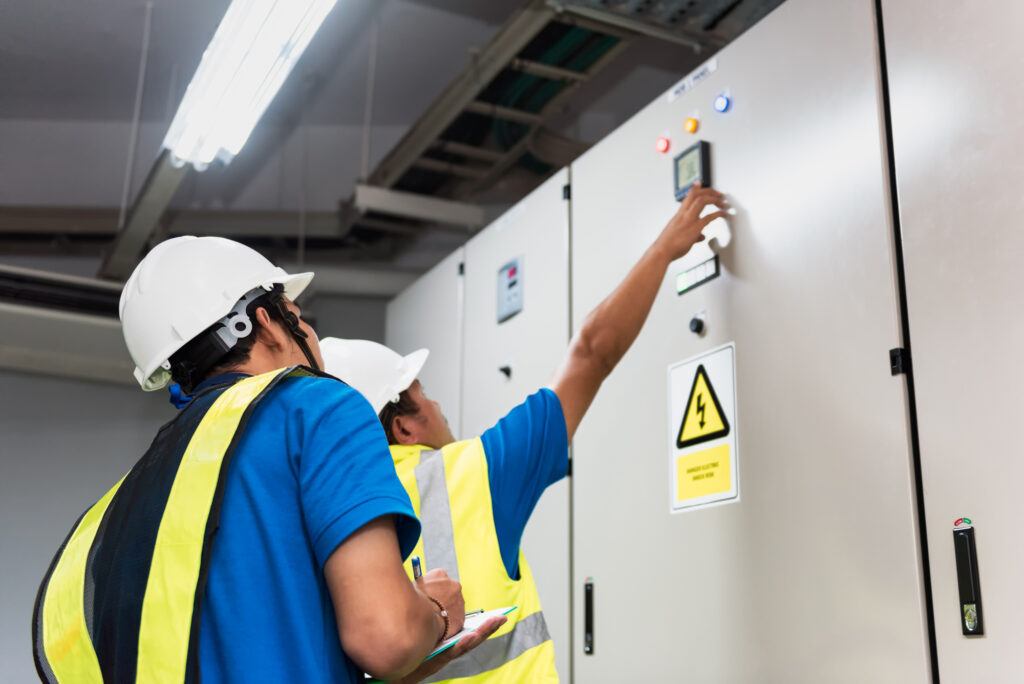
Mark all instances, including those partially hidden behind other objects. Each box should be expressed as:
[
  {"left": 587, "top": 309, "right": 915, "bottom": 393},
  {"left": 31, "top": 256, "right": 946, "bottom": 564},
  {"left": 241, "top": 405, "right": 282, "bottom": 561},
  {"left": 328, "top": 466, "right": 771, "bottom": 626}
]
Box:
[{"left": 33, "top": 368, "right": 312, "bottom": 684}]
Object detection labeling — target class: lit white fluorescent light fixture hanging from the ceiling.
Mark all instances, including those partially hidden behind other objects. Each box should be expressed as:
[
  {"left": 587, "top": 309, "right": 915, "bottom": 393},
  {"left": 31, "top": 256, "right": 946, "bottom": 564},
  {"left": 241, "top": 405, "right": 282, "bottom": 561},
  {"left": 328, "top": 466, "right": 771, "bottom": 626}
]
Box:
[{"left": 164, "top": 0, "right": 337, "bottom": 171}]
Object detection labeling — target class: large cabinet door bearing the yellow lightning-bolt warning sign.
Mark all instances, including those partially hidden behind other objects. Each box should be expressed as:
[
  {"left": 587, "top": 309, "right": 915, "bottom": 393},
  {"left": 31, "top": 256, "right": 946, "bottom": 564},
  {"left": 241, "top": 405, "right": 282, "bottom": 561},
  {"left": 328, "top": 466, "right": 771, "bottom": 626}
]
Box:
[{"left": 572, "top": 0, "right": 930, "bottom": 684}]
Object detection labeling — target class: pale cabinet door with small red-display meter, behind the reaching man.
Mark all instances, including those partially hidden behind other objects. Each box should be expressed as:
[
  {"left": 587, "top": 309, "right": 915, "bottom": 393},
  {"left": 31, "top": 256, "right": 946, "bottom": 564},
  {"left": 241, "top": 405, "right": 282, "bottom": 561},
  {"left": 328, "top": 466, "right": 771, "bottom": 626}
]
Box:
[{"left": 462, "top": 170, "right": 570, "bottom": 682}]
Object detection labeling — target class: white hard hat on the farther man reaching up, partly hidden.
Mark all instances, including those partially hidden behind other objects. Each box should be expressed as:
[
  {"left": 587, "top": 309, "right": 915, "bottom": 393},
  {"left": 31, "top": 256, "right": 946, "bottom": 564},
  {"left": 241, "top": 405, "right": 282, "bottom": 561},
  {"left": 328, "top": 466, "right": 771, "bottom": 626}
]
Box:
[{"left": 319, "top": 337, "right": 430, "bottom": 414}]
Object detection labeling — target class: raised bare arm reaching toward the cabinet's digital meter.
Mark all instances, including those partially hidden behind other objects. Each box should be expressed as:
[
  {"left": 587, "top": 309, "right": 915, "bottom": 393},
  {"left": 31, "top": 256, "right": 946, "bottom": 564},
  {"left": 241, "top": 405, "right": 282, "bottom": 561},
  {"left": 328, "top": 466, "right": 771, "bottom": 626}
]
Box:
[{"left": 550, "top": 184, "right": 726, "bottom": 440}]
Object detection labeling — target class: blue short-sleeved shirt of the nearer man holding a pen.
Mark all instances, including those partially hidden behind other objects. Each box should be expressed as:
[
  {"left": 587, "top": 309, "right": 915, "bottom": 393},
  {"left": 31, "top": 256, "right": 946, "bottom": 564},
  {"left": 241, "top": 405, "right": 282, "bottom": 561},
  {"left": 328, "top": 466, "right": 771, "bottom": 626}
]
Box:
[{"left": 190, "top": 376, "right": 420, "bottom": 684}]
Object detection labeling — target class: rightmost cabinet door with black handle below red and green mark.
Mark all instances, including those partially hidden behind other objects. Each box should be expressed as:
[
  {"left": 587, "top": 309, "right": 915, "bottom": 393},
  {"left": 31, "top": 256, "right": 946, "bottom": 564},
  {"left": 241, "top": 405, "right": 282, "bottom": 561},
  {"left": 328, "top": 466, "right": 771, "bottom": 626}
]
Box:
[{"left": 883, "top": 0, "right": 1024, "bottom": 682}]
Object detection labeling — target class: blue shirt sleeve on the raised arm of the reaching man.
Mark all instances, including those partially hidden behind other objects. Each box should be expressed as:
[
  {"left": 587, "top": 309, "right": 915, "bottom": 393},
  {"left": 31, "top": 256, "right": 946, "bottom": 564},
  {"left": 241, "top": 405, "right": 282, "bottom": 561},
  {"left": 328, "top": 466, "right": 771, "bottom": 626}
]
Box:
[{"left": 480, "top": 388, "right": 569, "bottom": 579}]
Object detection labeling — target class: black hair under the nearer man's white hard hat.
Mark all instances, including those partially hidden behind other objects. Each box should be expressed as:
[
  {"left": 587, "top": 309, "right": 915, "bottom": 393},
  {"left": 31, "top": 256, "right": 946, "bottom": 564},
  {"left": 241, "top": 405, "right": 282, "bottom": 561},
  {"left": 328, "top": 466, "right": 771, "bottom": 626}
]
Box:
[{"left": 169, "top": 284, "right": 295, "bottom": 392}]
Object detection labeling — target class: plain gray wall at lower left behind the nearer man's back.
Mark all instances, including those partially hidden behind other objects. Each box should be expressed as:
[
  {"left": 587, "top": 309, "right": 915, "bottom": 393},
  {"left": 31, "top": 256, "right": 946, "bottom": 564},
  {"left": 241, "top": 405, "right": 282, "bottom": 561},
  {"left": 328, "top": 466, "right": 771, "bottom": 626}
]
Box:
[{"left": 0, "top": 372, "right": 174, "bottom": 682}]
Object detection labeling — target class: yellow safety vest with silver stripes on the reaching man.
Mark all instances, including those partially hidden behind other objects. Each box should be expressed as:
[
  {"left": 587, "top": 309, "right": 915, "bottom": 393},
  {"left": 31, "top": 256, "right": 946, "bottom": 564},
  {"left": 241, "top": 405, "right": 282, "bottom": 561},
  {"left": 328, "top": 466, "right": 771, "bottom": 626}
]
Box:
[{"left": 391, "top": 438, "right": 558, "bottom": 684}]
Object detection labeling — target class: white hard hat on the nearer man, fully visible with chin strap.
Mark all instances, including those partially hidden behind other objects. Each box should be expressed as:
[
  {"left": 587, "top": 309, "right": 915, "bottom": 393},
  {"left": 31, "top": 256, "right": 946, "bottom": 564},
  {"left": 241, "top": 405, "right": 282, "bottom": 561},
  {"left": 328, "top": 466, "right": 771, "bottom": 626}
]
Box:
[{"left": 119, "top": 236, "right": 313, "bottom": 391}]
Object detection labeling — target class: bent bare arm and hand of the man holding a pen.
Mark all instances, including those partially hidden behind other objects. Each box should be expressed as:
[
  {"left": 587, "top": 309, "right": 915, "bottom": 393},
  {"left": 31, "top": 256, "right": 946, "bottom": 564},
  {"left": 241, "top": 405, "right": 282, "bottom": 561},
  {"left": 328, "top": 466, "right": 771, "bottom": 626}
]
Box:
[{"left": 324, "top": 515, "right": 466, "bottom": 681}]
